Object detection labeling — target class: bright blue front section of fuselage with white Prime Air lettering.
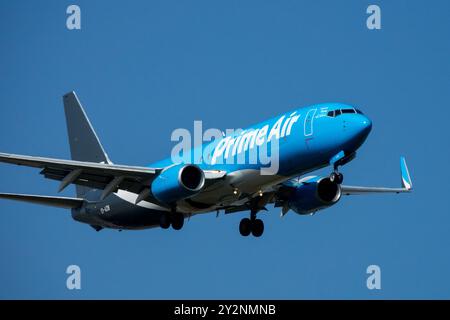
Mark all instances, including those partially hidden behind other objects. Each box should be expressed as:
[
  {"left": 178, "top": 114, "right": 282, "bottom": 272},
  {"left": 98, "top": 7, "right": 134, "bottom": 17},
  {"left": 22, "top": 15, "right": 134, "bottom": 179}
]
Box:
[{"left": 150, "top": 103, "right": 372, "bottom": 177}]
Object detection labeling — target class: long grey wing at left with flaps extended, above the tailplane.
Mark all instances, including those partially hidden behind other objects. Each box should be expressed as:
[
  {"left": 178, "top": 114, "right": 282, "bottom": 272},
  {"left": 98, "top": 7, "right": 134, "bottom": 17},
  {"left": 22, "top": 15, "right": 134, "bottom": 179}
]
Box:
[{"left": 0, "top": 153, "right": 161, "bottom": 196}]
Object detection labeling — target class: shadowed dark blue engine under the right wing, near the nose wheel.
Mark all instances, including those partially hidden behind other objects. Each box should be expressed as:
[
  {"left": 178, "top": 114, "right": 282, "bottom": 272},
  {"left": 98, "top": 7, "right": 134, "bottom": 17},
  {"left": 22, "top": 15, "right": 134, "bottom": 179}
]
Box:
[{"left": 288, "top": 178, "right": 341, "bottom": 214}]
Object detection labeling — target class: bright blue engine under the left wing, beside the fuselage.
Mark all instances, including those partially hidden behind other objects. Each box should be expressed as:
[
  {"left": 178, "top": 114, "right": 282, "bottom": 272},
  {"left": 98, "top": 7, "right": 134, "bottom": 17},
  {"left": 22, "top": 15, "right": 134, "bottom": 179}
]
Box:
[{"left": 151, "top": 164, "right": 205, "bottom": 204}]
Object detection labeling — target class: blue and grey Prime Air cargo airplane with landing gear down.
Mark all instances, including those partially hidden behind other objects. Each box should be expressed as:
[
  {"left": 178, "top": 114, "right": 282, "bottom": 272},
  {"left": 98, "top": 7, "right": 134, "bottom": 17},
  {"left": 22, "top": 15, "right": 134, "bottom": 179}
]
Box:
[{"left": 0, "top": 91, "right": 412, "bottom": 237}]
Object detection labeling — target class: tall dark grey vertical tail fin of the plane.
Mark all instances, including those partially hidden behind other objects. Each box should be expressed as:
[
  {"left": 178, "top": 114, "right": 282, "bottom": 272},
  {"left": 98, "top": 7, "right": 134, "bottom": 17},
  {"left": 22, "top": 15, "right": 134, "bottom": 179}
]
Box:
[{"left": 63, "top": 91, "right": 111, "bottom": 197}]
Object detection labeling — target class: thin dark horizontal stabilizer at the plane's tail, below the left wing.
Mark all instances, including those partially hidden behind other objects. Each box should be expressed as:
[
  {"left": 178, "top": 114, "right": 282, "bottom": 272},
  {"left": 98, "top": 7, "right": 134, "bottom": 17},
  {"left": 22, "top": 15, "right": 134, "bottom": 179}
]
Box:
[{"left": 0, "top": 193, "right": 84, "bottom": 209}]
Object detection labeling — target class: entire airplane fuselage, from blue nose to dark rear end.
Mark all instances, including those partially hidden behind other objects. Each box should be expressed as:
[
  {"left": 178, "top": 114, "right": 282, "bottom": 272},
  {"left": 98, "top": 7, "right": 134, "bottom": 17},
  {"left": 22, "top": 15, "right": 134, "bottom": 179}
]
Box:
[{"left": 73, "top": 103, "right": 372, "bottom": 229}]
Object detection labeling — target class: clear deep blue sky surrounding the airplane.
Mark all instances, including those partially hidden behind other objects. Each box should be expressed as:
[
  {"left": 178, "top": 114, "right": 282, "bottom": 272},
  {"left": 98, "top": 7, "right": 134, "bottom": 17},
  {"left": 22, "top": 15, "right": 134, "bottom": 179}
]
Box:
[{"left": 0, "top": 0, "right": 450, "bottom": 299}]
